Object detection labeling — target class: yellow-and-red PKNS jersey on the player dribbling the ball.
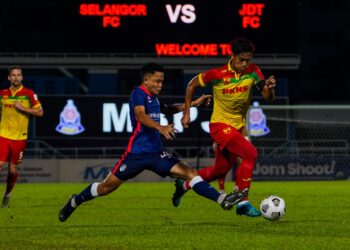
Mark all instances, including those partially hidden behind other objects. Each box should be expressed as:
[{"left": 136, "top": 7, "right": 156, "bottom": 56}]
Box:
[{"left": 199, "top": 61, "right": 264, "bottom": 129}]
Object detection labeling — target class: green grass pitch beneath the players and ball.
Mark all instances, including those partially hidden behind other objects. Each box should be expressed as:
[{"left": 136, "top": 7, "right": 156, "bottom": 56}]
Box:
[{"left": 0, "top": 181, "right": 350, "bottom": 249}]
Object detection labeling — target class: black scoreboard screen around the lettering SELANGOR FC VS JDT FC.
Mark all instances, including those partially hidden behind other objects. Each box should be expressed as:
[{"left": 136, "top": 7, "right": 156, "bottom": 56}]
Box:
[{"left": 0, "top": 0, "right": 298, "bottom": 53}]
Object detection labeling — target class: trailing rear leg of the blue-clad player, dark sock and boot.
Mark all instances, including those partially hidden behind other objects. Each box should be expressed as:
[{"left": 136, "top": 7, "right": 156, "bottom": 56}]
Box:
[{"left": 58, "top": 173, "right": 123, "bottom": 222}]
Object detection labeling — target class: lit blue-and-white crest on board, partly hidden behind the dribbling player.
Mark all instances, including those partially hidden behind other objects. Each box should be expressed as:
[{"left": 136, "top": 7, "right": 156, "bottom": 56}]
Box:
[{"left": 249, "top": 102, "right": 270, "bottom": 136}]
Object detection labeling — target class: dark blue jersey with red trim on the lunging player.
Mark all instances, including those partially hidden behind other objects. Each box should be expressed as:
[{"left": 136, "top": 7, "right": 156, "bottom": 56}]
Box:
[{"left": 126, "top": 86, "right": 163, "bottom": 154}]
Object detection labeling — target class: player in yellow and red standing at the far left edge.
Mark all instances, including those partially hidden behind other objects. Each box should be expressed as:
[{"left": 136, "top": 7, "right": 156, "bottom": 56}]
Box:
[{"left": 0, "top": 66, "right": 44, "bottom": 208}]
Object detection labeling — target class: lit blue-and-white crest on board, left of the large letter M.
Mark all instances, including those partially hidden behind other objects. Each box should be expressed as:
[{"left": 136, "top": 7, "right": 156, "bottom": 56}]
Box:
[{"left": 56, "top": 99, "right": 85, "bottom": 135}]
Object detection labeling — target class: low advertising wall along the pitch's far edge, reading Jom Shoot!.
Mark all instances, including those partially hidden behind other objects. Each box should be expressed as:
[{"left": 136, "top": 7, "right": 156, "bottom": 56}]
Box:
[{"left": 0, "top": 157, "right": 350, "bottom": 183}]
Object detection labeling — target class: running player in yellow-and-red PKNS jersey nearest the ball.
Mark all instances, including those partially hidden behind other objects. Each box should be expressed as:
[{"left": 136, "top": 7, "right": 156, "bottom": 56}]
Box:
[{"left": 173, "top": 38, "right": 276, "bottom": 217}]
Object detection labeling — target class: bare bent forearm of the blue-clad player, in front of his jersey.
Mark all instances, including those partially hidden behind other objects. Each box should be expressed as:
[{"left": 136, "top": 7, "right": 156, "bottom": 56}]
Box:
[{"left": 134, "top": 105, "right": 175, "bottom": 140}]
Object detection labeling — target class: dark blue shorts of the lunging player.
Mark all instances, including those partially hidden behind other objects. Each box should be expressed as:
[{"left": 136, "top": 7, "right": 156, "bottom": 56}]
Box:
[{"left": 112, "top": 152, "right": 180, "bottom": 181}]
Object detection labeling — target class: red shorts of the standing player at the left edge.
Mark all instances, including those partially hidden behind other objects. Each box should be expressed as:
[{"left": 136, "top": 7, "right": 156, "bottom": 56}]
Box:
[{"left": 0, "top": 136, "right": 27, "bottom": 164}]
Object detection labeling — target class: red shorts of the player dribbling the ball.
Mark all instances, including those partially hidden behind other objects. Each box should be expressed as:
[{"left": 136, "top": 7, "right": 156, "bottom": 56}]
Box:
[{"left": 209, "top": 122, "right": 242, "bottom": 150}]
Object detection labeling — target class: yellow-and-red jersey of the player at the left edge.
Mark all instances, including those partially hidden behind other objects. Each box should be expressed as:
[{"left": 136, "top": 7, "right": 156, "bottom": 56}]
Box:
[{"left": 0, "top": 86, "right": 41, "bottom": 140}]
